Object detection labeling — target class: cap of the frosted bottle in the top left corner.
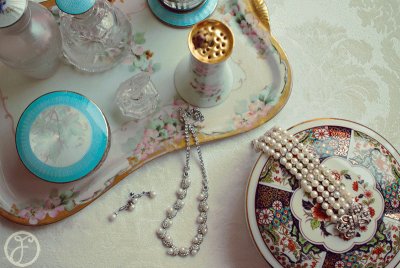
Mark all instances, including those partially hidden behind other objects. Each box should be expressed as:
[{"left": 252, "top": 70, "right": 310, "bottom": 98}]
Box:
[{"left": 0, "top": 0, "right": 28, "bottom": 28}]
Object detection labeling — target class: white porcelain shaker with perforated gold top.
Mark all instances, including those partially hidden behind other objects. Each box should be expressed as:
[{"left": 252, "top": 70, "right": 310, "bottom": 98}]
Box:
[{"left": 175, "top": 19, "right": 234, "bottom": 108}]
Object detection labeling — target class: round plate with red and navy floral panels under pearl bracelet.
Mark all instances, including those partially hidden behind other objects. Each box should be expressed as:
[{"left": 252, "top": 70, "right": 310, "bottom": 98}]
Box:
[{"left": 246, "top": 119, "right": 400, "bottom": 268}]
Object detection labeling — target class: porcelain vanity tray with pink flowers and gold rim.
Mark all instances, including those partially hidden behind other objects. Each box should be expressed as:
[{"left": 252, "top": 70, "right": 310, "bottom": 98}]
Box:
[{"left": 0, "top": 0, "right": 291, "bottom": 225}]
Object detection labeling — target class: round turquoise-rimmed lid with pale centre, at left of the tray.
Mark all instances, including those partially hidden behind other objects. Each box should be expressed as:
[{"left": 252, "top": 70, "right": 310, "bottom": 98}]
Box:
[{"left": 16, "top": 91, "right": 110, "bottom": 183}]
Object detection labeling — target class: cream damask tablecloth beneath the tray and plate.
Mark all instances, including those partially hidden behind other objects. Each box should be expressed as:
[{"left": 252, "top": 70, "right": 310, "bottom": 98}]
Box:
[{"left": 0, "top": 0, "right": 400, "bottom": 268}]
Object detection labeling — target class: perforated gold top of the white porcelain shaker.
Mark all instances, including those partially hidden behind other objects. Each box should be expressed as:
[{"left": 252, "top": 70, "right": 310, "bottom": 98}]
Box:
[{"left": 188, "top": 19, "right": 234, "bottom": 64}]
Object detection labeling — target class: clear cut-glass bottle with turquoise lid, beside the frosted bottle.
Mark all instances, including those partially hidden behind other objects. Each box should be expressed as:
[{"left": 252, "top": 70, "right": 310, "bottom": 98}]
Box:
[{"left": 56, "top": 0, "right": 132, "bottom": 72}]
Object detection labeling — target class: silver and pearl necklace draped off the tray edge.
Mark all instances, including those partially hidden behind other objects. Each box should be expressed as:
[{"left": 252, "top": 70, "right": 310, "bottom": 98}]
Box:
[{"left": 157, "top": 108, "right": 209, "bottom": 257}]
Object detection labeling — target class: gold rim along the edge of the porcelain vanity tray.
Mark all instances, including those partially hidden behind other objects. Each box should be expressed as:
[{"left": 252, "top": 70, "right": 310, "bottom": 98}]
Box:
[{"left": 0, "top": 0, "right": 292, "bottom": 226}]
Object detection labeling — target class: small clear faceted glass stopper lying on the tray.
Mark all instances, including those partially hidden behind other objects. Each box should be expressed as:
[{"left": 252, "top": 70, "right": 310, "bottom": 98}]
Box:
[{"left": 116, "top": 72, "right": 159, "bottom": 119}]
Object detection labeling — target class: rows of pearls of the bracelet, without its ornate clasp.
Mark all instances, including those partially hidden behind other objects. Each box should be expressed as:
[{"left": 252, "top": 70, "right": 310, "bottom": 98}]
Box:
[{"left": 253, "top": 127, "right": 353, "bottom": 223}]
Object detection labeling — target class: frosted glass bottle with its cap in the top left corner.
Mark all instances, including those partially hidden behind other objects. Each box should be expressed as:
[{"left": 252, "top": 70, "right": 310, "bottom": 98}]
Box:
[{"left": 0, "top": 0, "right": 62, "bottom": 79}]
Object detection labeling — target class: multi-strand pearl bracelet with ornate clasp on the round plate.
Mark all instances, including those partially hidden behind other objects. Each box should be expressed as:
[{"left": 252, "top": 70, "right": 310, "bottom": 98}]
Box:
[{"left": 253, "top": 127, "right": 371, "bottom": 240}]
